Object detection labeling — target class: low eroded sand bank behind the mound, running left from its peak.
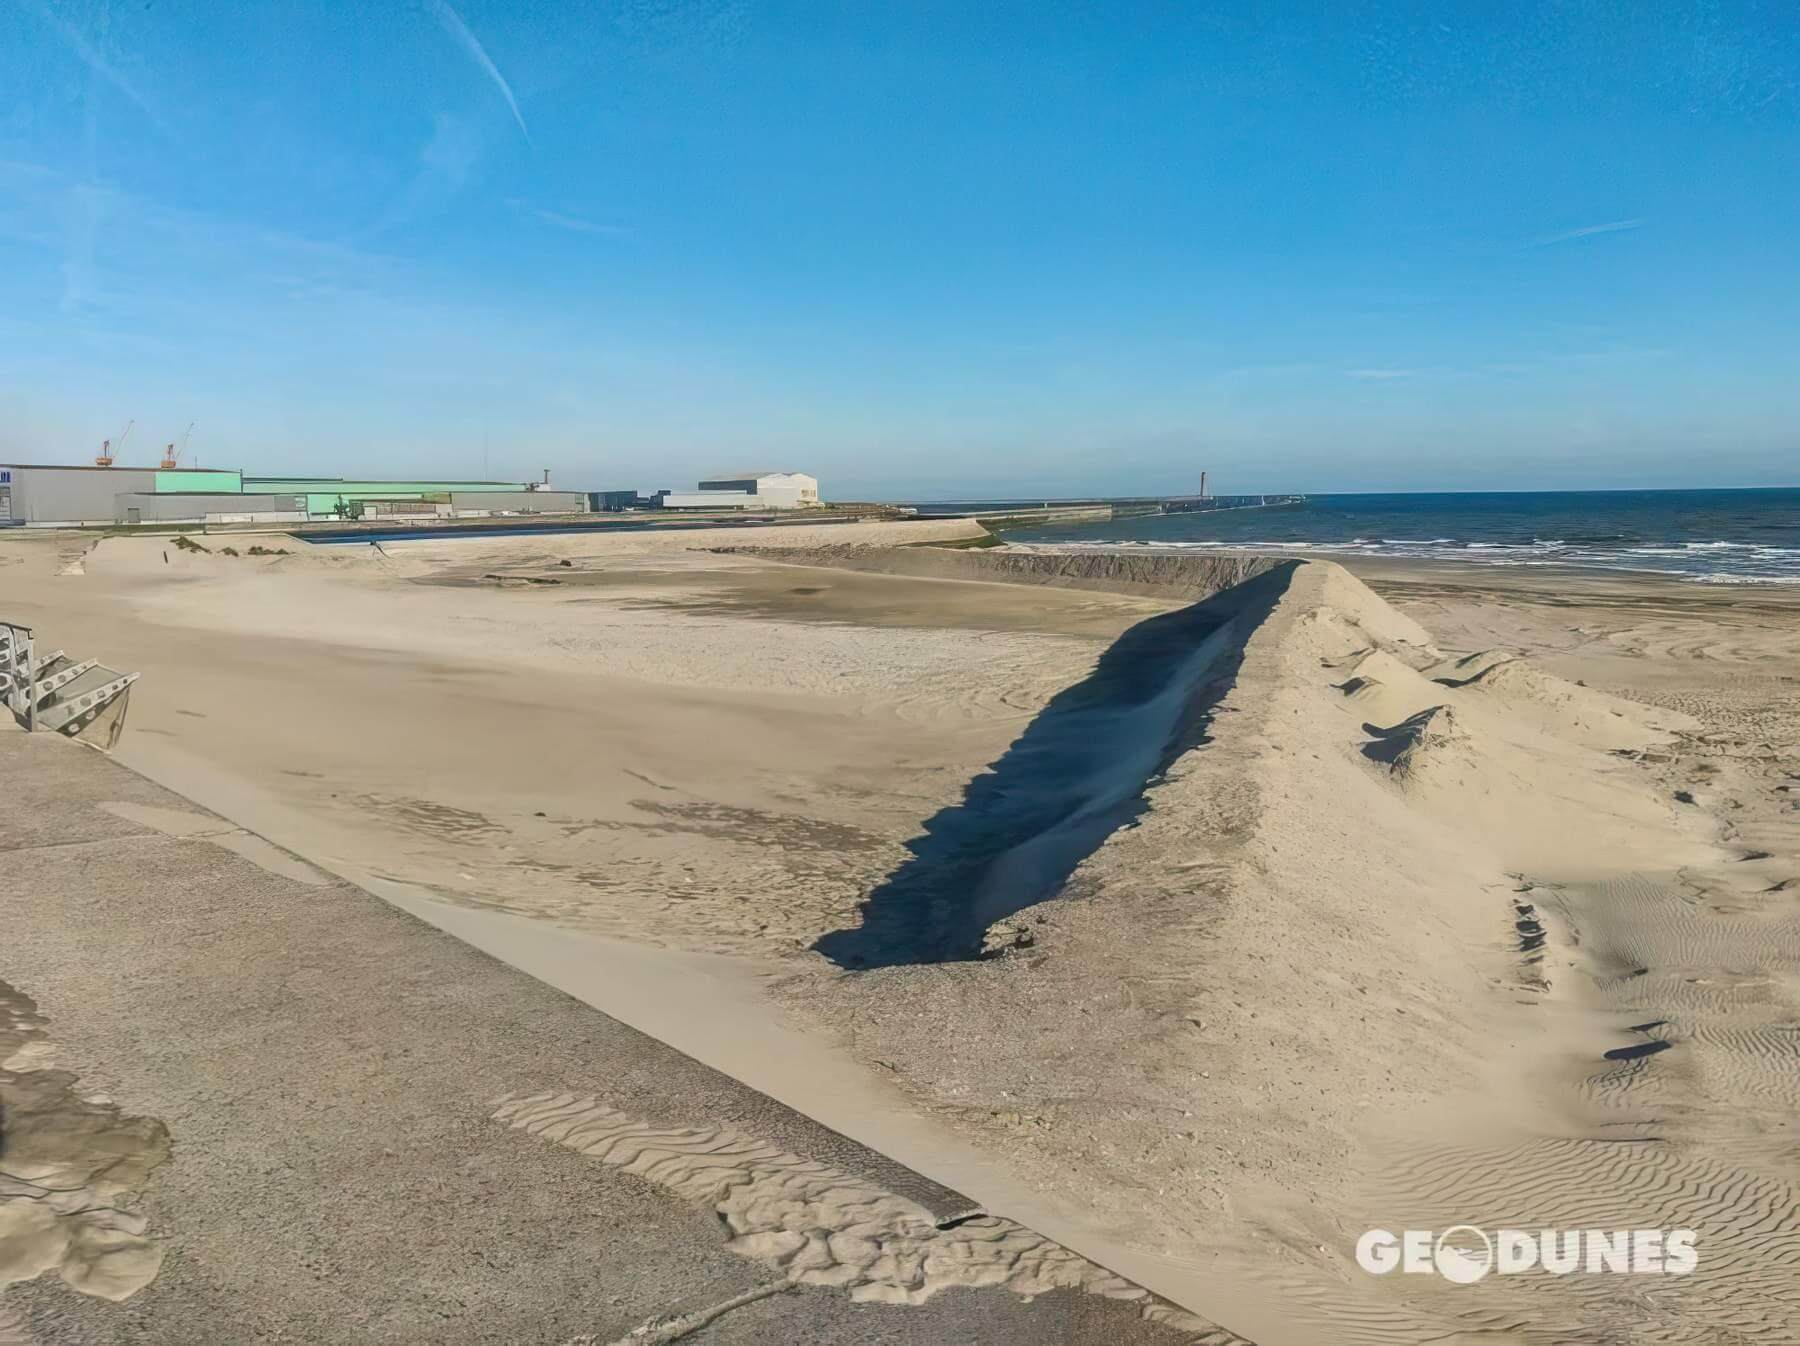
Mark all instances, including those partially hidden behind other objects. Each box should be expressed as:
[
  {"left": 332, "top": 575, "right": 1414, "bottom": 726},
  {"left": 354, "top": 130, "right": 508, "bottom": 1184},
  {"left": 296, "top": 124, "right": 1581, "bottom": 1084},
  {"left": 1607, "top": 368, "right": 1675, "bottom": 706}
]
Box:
[{"left": 716, "top": 545, "right": 1303, "bottom": 603}]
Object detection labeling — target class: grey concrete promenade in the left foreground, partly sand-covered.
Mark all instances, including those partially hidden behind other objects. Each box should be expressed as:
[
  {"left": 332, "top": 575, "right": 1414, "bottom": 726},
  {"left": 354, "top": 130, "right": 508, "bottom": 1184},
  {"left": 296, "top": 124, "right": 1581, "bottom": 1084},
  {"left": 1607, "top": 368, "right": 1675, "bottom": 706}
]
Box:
[{"left": 0, "top": 729, "right": 1188, "bottom": 1346}]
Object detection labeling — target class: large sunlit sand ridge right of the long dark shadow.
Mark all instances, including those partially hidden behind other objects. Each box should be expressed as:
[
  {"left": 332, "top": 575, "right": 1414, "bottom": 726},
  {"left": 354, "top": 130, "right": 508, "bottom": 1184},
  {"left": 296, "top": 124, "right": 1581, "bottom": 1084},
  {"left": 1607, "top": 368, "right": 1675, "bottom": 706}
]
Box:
[{"left": 797, "top": 563, "right": 1778, "bottom": 1342}]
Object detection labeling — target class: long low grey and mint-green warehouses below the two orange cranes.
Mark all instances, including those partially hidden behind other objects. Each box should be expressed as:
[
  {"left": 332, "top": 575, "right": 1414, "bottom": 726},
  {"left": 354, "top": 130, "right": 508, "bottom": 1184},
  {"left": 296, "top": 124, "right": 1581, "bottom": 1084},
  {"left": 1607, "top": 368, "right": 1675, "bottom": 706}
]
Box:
[{"left": 0, "top": 462, "right": 587, "bottom": 527}]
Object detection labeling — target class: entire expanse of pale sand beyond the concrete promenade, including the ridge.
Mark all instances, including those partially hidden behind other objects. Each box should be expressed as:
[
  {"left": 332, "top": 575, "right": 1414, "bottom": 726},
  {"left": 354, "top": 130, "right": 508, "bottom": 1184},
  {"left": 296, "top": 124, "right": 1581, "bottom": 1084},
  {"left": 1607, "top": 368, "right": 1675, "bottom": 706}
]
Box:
[{"left": 0, "top": 525, "right": 1800, "bottom": 1346}]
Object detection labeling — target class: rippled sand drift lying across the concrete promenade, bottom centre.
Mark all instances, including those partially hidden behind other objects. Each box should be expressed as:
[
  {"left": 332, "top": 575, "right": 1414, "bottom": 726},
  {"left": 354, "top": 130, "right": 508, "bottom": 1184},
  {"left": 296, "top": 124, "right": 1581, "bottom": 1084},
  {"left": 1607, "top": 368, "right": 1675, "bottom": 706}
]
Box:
[{"left": 493, "top": 1094, "right": 1249, "bottom": 1346}]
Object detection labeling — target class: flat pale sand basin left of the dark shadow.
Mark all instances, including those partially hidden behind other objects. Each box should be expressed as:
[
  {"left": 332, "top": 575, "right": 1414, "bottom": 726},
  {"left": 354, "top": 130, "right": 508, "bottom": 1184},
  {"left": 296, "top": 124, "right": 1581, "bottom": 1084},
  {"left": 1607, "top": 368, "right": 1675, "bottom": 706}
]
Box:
[{"left": 10, "top": 524, "right": 1159, "bottom": 954}]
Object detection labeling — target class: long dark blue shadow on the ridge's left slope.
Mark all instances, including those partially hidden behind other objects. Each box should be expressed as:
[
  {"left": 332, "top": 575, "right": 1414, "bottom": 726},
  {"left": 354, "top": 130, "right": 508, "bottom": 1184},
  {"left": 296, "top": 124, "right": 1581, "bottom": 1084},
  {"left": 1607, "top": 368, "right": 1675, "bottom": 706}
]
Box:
[{"left": 814, "top": 567, "right": 1291, "bottom": 970}]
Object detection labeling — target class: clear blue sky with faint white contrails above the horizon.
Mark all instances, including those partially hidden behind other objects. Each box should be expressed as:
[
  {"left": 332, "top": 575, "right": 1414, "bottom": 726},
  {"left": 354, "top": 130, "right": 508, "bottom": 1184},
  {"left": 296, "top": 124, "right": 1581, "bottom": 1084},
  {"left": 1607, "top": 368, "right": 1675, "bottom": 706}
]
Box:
[{"left": 0, "top": 0, "right": 1800, "bottom": 498}]
